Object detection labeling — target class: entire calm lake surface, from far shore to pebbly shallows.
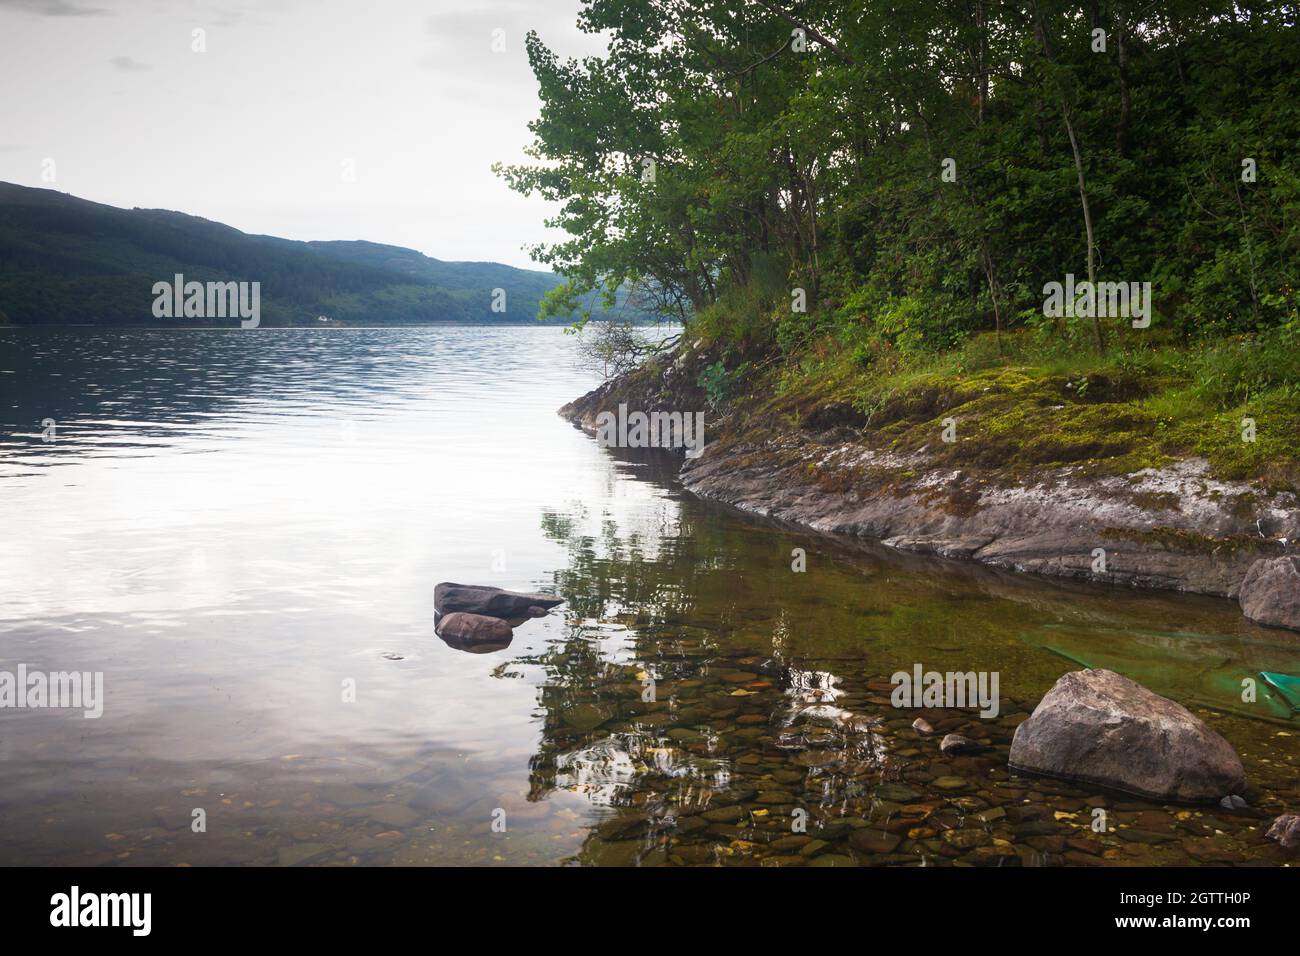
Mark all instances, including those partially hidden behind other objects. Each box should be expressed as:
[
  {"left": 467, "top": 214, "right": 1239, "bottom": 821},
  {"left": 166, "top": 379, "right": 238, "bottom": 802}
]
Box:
[{"left": 0, "top": 328, "right": 1300, "bottom": 866}]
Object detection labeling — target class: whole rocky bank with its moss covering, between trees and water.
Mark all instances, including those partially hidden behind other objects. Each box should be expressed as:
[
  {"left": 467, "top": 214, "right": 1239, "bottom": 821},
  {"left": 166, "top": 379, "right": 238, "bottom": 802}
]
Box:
[{"left": 560, "top": 339, "right": 1300, "bottom": 628}]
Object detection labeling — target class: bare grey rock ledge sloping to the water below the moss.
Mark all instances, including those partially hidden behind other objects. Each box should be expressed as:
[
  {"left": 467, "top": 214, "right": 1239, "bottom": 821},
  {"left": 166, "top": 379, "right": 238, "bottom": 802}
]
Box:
[{"left": 559, "top": 350, "right": 1300, "bottom": 630}]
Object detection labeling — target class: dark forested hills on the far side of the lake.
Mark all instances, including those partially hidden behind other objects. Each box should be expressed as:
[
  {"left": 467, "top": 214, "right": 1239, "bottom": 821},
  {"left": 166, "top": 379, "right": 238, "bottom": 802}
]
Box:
[{"left": 0, "top": 182, "right": 634, "bottom": 325}]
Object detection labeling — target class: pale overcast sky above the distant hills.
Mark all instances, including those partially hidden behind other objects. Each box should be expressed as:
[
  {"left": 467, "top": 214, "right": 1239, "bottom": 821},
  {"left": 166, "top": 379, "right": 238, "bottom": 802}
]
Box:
[{"left": 0, "top": 0, "right": 603, "bottom": 268}]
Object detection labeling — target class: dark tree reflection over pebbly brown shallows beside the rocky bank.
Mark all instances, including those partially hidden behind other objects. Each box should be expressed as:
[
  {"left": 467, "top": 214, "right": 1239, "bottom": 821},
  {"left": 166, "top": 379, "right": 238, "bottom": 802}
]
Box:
[{"left": 504, "top": 454, "right": 1289, "bottom": 865}]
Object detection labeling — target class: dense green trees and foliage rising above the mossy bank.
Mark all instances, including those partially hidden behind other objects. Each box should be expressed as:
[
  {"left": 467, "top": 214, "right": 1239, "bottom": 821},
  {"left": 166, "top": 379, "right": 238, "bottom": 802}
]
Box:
[{"left": 501, "top": 0, "right": 1300, "bottom": 367}]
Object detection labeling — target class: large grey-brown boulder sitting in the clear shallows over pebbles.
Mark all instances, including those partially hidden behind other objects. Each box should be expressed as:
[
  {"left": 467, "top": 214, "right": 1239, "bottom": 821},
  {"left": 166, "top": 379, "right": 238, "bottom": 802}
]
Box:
[{"left": 1008, "top": 670, "right": 1245, "bottom": 803}]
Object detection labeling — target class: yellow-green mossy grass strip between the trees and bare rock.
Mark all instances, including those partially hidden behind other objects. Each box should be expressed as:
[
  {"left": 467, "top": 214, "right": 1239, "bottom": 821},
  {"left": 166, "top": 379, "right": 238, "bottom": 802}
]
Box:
[{"left": 707, "top": 332, "right": 1300, "bottom": 490}]
